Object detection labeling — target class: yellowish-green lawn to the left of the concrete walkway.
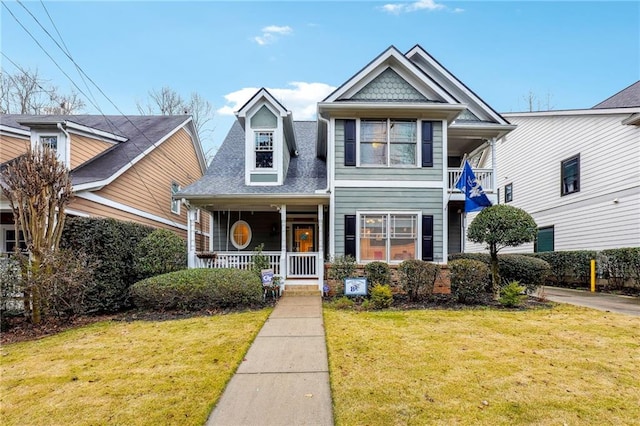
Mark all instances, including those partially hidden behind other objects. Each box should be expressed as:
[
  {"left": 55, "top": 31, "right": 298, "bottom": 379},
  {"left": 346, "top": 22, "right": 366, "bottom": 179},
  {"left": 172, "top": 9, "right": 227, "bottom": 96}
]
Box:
[{"left": 0, "top": 309, "right": 271, "bottom": 426}]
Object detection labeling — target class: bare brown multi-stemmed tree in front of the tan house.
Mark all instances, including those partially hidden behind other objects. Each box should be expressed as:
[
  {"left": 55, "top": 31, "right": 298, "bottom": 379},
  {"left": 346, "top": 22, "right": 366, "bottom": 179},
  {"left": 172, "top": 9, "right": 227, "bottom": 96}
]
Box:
[{"left": 0, "top": 146, "right": 72, "bottom": 324}]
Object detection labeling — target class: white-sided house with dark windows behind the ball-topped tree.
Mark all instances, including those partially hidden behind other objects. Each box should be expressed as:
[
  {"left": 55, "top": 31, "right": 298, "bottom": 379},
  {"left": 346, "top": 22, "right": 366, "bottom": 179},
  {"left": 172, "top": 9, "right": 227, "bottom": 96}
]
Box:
[{"left": 469, "top": 81, "right": 640, "bottom": 252}]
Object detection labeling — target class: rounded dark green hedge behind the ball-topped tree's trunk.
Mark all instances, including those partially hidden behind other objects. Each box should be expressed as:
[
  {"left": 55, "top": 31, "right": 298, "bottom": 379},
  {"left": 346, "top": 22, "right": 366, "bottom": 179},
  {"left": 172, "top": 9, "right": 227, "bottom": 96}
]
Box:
[{"left": 449, "top": 253, "right": 551, "bottom": 291}]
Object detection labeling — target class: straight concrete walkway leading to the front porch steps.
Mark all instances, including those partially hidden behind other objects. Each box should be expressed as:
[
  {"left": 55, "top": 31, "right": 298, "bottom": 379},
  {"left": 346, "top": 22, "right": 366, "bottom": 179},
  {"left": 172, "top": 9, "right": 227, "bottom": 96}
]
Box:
[{"left": 207, "top": 296, "right": 333, "bottom": 426}]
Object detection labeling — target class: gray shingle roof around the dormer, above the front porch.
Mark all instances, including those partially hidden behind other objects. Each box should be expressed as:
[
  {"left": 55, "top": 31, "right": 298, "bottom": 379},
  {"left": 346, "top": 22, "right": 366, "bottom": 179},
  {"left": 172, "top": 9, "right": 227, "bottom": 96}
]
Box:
[{"left": 180, "top": 121, "right": 327, "bottom": 197}]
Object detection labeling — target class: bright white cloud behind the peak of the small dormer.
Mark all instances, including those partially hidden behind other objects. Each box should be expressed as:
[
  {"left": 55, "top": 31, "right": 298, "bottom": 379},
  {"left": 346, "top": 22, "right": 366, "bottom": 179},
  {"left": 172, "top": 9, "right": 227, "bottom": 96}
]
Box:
[{"left": 217, "top": 81, "right": 336, "bottom": 120}]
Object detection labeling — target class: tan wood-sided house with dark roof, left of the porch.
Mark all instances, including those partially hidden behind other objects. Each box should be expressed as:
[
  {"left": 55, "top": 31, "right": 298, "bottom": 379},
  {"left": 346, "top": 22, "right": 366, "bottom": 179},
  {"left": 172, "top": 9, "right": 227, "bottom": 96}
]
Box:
[{"left": 0, "top": 115, "right": 210, "bottom": 253}]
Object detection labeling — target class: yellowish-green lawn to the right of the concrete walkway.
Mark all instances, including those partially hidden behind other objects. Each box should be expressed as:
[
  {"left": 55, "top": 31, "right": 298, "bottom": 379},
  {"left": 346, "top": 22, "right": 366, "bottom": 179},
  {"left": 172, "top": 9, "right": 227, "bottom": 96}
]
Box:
[{"left": 324, "top": 306, "right": 640, "bottom": 425}]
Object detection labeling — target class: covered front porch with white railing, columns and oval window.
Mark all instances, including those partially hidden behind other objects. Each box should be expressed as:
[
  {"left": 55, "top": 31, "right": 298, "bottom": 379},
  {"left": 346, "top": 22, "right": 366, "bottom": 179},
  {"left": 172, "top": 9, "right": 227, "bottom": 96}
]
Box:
[{"left": 188, "top": 199, "right": 328, "bottom": 289}]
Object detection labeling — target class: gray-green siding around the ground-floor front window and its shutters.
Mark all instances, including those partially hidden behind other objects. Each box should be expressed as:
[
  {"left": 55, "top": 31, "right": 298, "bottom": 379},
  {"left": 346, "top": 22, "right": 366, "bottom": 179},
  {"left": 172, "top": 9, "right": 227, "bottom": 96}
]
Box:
[{"left": 334, "top": 188, "right": 443, "bottom": 261}]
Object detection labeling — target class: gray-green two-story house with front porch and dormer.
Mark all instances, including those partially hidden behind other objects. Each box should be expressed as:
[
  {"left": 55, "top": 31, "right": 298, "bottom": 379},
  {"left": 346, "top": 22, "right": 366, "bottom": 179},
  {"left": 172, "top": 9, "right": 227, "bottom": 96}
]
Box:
[{"left": 179, "top": 46, "right": 515, "bottom": 288}]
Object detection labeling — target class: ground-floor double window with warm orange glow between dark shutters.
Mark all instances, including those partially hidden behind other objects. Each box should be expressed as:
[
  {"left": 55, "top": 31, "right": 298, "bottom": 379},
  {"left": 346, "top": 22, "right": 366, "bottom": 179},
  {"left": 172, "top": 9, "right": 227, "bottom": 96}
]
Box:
[{"left": 359, "top": 213, "right": 418, "bottom": 263}]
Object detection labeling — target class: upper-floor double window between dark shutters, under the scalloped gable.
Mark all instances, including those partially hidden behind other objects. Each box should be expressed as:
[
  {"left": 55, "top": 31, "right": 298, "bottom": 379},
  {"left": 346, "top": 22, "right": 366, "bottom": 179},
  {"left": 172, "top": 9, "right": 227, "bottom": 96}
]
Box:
[{"left": 360, "top": 119, "right": 418, "bottom": 167}]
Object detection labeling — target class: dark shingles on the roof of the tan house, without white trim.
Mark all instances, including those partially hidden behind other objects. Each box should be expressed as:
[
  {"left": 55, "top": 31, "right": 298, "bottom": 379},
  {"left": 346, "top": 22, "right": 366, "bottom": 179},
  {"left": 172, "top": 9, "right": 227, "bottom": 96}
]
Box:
[{"left": 0, "top": 114, "right": 194, "bottom": 185}]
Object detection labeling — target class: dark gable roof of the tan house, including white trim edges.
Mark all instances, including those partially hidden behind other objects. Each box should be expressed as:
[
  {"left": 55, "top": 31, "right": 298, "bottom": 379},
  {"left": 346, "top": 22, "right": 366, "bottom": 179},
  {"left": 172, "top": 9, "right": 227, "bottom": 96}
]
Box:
[{"left": 0, "top": 114, "right": 206, "bottom": 190}]
